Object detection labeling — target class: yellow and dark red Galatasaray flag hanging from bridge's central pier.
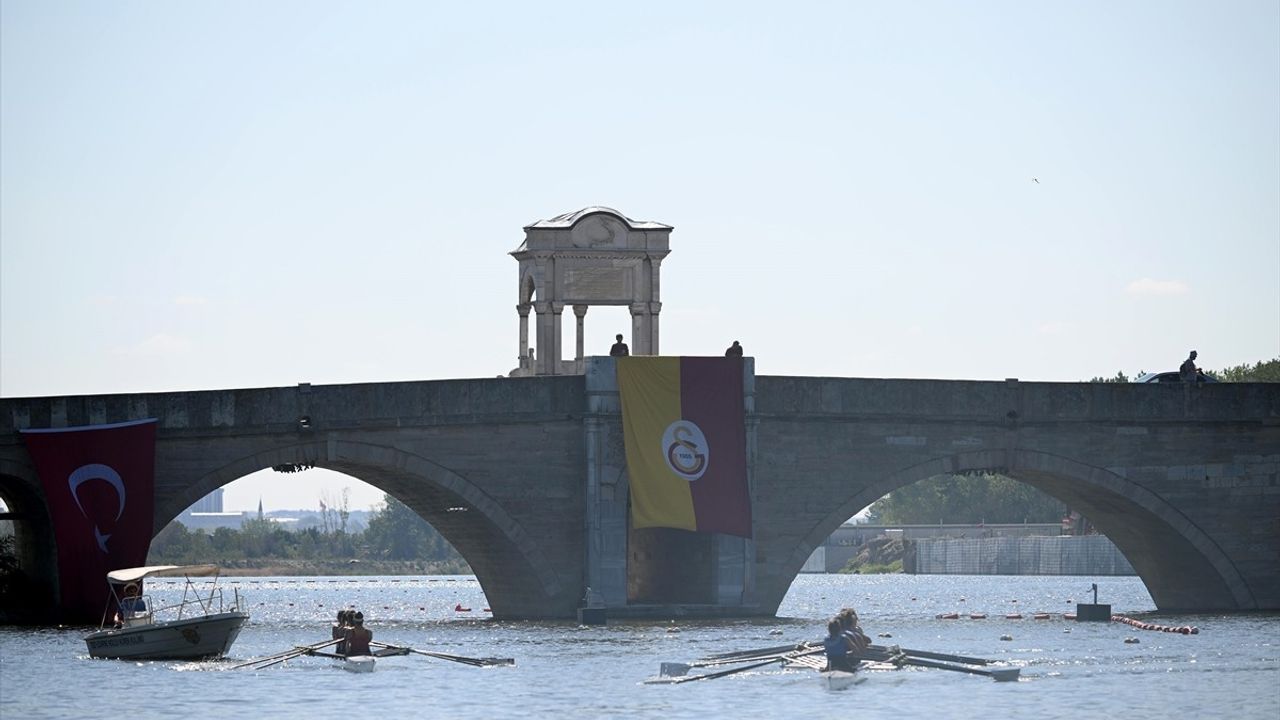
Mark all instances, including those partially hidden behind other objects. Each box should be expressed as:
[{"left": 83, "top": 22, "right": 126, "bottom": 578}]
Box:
[{"left": 617, "top": 356, "right": 751, "bottom": 538}]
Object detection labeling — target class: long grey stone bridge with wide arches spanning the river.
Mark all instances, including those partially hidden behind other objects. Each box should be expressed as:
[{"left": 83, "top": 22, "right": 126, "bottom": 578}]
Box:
[{"left": 0, "top": 357, "right": 1280, "bottom": 619}]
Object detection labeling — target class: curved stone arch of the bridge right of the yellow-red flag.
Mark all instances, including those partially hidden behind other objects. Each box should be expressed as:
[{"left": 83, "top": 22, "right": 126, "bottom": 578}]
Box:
[{"left": 786, "top": 450, "right": 1258, "bottom": 611}]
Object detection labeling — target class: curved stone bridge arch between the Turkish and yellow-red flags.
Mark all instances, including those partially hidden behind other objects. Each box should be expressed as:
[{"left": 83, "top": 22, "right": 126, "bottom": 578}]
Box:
[{"left": 168, "top": 439, "right": 565, "bottom": 619}]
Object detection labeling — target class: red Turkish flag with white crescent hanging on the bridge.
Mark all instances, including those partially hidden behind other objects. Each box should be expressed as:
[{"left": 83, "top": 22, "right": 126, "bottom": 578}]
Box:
[{"left": 22, "top": 419, "right": 156, "bottom": 623}]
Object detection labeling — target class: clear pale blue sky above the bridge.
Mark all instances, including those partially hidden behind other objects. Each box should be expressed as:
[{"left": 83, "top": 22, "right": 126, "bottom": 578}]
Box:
[{"left": 0, "top": 0, "right": 1280, "bottom": 507}]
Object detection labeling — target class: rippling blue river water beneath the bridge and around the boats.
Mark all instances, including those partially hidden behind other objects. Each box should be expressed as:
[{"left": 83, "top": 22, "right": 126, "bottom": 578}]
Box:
[{"left": 0, "top": 575, "right": 1280, "bottom": 720}]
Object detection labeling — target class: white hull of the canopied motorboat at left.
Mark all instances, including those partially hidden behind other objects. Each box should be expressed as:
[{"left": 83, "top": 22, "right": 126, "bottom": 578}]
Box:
[{"left": 84, "top": 612, "right": 248, "bottom": 660}]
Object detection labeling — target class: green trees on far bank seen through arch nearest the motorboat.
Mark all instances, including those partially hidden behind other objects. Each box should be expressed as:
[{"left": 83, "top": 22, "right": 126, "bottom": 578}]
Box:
[{"left": 147, "top": 495, "right": 470, "bottom": 573}]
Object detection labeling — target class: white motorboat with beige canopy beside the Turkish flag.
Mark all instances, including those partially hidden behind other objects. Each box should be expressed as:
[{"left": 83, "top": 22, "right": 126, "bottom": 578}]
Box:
[{"left": 84, "top": 565, "right": 248, "bottom": 660}]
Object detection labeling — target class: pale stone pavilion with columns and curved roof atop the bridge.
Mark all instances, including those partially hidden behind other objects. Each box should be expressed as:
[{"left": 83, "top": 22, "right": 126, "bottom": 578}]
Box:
[{"left": 509, "top": 205, "right": 673, "bottom": 375}]
